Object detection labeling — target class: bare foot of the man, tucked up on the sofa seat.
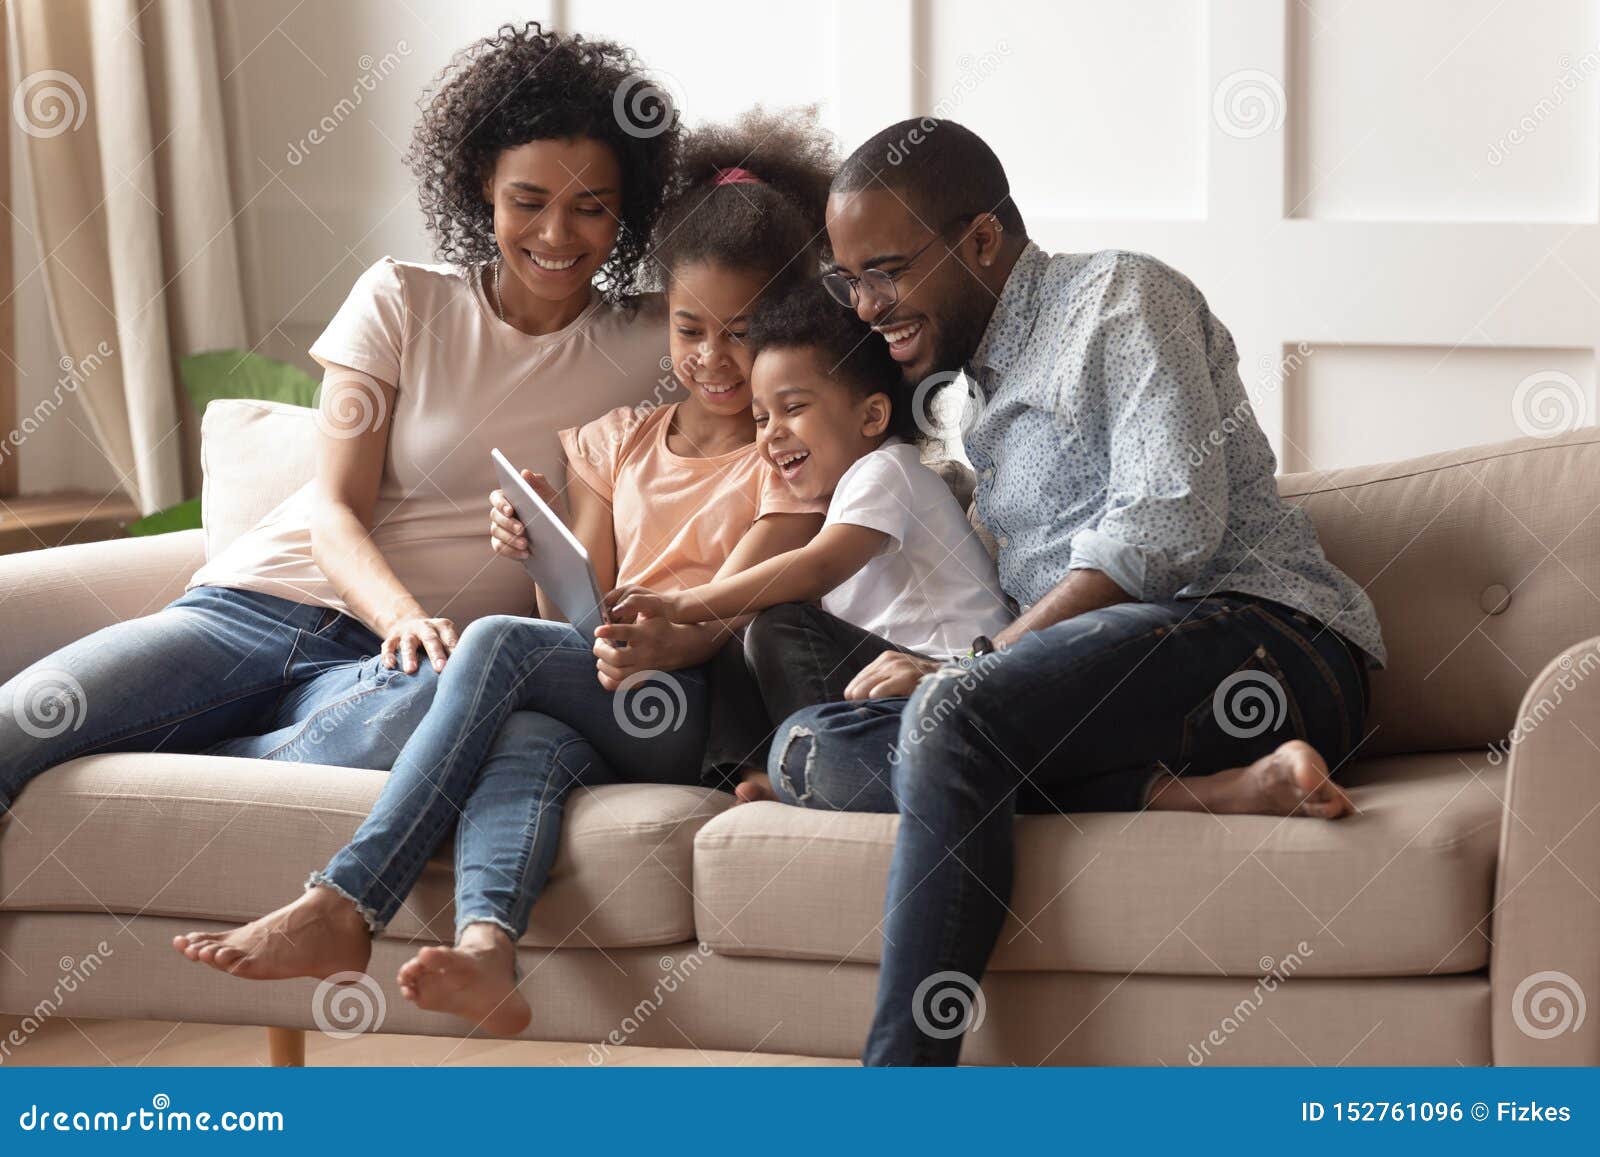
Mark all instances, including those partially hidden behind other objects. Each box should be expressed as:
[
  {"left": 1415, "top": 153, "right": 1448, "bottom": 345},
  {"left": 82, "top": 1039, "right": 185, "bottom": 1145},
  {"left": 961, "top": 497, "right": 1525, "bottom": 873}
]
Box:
[{"left": 1150, "top": 739, "right": 1355, "bottom": 819}]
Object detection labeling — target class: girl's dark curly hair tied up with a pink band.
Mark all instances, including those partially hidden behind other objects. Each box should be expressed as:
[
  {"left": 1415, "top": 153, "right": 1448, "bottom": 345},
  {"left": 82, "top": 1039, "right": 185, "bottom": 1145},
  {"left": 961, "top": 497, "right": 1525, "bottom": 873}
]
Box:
[{"left": 653, "top": 107, "right": 838, "bottom": 293}]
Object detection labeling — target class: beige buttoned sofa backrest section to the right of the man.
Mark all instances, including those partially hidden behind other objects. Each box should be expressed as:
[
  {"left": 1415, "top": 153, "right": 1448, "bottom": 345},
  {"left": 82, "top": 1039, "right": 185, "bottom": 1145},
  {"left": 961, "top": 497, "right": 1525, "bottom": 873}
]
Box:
[{"left": 1278, "top": 427, "right": 1600, "bottom": 757}]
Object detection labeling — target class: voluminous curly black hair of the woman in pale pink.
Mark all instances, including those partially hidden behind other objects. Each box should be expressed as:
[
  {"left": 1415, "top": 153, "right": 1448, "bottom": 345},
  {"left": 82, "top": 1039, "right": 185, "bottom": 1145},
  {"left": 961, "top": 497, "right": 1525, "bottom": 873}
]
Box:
[{"left": 406, "top": 21, "right": 682, "bottom": 301}]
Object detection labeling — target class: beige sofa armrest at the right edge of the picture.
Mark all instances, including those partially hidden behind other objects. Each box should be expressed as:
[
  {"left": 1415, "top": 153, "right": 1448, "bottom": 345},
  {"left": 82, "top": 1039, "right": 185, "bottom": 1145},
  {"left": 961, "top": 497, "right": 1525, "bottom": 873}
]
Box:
[{"left": 1490, "top": 639, "right": 1600, "bottom": 1064}]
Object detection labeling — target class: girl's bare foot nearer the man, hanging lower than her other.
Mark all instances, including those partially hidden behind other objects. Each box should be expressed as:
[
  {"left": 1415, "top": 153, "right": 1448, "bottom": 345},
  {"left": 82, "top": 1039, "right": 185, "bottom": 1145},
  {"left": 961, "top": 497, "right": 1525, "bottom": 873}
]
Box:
[{"left": 397, "top": 923, "right": 533, "bottom": 1037}]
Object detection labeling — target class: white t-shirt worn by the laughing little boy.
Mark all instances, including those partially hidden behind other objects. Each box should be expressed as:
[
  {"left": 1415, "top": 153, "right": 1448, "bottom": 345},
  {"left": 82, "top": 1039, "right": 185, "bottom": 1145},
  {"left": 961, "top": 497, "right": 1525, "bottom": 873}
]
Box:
[{"left": 822, "top": 438, "right": 1011, "bottom": 659}]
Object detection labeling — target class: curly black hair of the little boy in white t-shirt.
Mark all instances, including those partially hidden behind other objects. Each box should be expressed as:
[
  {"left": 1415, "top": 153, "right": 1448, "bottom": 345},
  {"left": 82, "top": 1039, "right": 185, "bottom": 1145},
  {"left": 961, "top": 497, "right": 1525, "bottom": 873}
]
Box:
[{"left": 746, "top": 282, "right": 926, "bottom": 443}]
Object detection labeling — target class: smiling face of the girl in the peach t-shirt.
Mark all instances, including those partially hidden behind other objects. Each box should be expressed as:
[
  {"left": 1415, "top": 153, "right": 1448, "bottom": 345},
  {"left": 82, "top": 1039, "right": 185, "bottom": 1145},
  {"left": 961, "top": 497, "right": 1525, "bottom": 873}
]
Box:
[{"left": 667, "top": 262, "right": 768, "bottom": 416}]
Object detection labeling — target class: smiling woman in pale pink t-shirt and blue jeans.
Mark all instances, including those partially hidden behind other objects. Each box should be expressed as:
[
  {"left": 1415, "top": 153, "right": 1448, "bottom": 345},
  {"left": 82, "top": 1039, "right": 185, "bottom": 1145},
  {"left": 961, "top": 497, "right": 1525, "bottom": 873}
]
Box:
[{"left": 0, "top": 24, "right": 678, "bottom": 813}]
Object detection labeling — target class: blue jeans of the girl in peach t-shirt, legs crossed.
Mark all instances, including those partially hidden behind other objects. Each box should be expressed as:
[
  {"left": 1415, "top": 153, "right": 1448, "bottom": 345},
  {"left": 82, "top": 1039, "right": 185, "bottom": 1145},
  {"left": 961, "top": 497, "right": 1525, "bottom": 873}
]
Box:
[{"left": 310, "top": 615, "right": 706, "bottom": 941}]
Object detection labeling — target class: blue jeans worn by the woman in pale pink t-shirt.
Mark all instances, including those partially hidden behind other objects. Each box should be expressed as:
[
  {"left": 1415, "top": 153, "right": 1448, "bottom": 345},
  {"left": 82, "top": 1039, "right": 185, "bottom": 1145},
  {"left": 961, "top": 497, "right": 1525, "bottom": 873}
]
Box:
[{"left": 0, "top": 587, "right": 434, "bottom": 813}]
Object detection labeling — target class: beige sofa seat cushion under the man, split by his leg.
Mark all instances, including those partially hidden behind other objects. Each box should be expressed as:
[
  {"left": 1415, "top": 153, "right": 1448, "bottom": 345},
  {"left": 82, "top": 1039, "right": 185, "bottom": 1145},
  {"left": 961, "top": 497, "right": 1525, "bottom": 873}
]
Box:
[{"left": 694, "top": 752, "right": 1504, "bottom": 976}]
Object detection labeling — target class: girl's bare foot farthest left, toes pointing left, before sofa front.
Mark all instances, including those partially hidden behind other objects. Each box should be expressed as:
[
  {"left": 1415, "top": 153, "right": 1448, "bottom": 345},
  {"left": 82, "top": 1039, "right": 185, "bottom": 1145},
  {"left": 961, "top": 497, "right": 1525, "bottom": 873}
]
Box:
[{"left": 173, "top": 887, "right": 373, "bottom": 981}]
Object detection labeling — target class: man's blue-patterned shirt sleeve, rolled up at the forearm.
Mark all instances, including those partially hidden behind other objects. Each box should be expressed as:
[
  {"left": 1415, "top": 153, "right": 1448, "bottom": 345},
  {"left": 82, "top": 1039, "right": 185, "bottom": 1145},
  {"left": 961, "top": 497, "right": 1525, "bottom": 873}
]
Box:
[{"left": 1069, "top": 254, "right": 1237, "bottom": 602}]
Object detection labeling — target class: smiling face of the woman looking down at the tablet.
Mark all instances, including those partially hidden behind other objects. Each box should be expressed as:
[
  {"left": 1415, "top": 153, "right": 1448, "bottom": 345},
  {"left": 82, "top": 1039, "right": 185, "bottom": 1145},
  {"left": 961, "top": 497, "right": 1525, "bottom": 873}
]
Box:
[{"left": 483, "top": 138, "right": 622, "bottom": 302}]
